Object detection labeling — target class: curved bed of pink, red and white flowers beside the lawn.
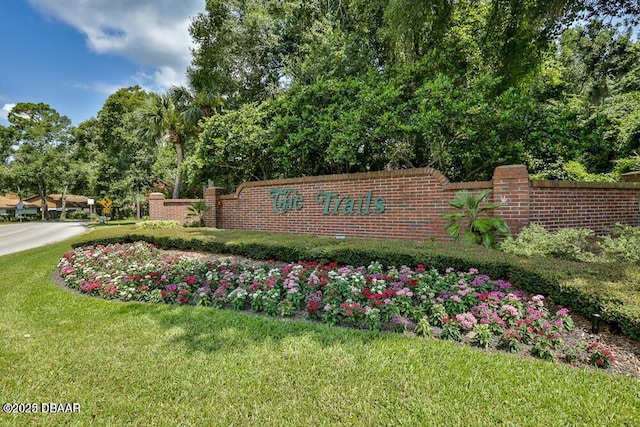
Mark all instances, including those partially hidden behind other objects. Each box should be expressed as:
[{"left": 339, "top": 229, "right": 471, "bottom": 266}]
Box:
[{"left": 58, "top": 242, "right": 615, "bottom": 368}]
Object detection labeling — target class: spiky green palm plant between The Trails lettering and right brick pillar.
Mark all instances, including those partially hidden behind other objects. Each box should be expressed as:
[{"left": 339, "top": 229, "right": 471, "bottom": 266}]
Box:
[{"left": 442, "top": 190, "right": 509, "bottom": 248}]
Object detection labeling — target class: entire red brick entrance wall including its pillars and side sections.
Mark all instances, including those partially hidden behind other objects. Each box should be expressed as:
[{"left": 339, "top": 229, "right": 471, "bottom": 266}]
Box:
[{"left": 149, "top": 165, "right": 640, "bottom": 240}]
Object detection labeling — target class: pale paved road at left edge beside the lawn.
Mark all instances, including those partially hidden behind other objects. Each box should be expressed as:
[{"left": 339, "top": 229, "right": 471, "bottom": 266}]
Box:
[{"left": 0, "top": 222, "right": 87, "bottom": 255}]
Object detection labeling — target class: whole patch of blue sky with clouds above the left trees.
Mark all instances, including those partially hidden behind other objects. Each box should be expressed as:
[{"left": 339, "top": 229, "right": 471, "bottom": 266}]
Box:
[{"left": 0, "top": 0, "right": 205, "bottom": 126}]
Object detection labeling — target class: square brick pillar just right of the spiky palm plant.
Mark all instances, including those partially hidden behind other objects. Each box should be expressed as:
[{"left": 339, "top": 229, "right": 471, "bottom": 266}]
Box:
[{"left": 492, "top": 165, "right": 529, "bottom": 235}]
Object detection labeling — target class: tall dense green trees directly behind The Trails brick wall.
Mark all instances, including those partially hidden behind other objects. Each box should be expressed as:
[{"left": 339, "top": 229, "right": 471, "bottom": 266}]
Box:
[{"left": 180, "top": 0, "right": 640, "bottom": 190}]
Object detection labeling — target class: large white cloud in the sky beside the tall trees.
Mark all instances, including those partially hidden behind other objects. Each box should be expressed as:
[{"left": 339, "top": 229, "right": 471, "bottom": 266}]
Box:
[{"left": 29, "top": 0, "right": 205, "bottom": 90}]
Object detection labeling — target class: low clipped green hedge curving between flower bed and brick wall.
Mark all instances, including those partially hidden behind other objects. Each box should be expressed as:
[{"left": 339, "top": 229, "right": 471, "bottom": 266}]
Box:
[{"left": 74, "top": 231, "right": 640, "bottom": 339}]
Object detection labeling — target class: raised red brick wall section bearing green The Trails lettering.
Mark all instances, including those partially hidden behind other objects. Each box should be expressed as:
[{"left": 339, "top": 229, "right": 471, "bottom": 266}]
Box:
[{"left": 205, "top": 168, "right": 491, "bottom": 240}]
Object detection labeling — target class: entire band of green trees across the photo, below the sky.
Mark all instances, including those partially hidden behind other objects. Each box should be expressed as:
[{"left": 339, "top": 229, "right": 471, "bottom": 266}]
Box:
[{"left": 5, "top": 0, "right": 640, "bottom": 219}]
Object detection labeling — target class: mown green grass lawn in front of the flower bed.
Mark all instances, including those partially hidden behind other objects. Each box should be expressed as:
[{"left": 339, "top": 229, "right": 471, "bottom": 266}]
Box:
[{"left": 0, "top": 227, "right": 640, "bottom": 426}]
